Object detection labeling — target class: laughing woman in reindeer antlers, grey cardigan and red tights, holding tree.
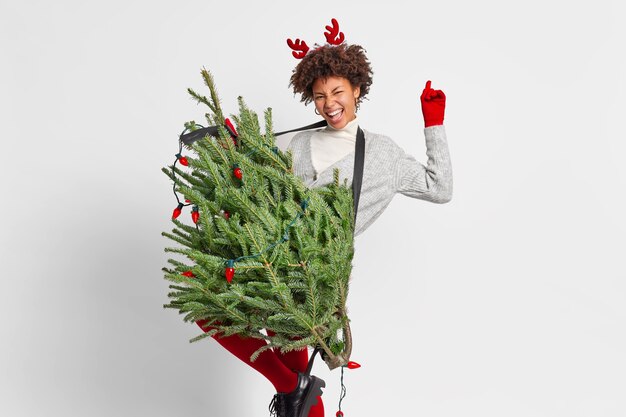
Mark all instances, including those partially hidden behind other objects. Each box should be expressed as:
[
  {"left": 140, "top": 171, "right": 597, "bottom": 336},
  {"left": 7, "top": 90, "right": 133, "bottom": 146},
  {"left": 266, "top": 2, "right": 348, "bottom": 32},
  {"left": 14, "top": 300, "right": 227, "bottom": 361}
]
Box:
[{"left": 198, "top": 19, "right": 452, "bottom": 417}]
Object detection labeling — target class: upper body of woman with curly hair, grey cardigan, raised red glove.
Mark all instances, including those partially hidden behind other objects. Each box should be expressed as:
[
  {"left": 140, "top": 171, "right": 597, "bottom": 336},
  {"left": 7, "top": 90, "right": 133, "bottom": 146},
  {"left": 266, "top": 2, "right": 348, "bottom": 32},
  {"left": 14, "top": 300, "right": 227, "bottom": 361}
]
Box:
[{"left": 289, "top": 44, "right": 452, "bottom": 240}]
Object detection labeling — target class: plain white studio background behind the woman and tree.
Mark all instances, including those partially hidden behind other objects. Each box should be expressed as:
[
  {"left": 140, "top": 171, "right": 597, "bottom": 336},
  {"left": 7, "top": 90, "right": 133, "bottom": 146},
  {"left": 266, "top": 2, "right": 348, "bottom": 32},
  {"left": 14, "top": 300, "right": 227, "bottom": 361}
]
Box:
[{"left": 0, "top": 0, "right": 626, "bottom": 417}]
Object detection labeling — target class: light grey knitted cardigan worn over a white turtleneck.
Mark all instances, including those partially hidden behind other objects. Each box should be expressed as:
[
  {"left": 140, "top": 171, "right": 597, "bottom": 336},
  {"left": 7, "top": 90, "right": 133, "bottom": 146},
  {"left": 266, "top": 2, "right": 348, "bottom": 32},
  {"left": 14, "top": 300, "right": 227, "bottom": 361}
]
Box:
[{"left": 287, "top": 125, "right": 452, "bottom": 236}]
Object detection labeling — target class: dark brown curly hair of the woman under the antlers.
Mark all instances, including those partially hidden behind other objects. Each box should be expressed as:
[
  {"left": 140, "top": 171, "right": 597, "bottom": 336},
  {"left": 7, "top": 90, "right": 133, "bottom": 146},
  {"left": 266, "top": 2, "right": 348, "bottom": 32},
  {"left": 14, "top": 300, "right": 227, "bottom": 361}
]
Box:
[{"left": 289, "top": 44, "right": 373, "bottom": 106}]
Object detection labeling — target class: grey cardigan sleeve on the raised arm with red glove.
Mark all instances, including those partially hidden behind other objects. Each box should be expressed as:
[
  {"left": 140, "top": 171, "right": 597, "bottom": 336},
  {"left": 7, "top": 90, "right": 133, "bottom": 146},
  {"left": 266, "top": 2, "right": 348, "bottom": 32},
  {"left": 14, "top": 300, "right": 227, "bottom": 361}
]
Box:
[{"left": 394, "top": 125, "right": 452, "bottom": 203}]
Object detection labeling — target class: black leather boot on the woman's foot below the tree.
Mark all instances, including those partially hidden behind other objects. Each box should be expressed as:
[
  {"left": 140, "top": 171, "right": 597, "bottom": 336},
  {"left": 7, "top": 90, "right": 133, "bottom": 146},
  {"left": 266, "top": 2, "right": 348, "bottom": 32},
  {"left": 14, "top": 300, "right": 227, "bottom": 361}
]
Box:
[{"left": 270, "top": 350, "right": 326, "bottom": 417}]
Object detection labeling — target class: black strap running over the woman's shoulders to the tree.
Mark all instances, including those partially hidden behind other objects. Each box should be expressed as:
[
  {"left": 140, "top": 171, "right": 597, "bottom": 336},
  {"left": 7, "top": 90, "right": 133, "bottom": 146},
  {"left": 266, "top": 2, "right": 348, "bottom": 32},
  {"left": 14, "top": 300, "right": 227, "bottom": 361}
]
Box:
[{"left": 180, "top": 120, "right": 365, "bottom": 223}]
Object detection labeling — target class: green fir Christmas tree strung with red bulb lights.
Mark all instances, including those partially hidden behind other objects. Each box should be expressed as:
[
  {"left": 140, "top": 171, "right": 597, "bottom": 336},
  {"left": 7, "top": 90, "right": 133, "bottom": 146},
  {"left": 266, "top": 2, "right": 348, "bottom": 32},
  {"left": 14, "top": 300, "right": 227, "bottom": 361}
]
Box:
[{"left": 163, "top": 70, "right": 354, "bottom": 369}]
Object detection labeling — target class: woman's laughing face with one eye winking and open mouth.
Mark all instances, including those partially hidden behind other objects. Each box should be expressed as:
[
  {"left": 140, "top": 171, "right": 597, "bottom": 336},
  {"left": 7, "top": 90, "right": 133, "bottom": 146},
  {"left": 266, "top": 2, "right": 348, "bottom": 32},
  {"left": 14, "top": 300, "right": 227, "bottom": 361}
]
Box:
[{"left": 312, "top": 76, "right": 360, "bottom": 129}]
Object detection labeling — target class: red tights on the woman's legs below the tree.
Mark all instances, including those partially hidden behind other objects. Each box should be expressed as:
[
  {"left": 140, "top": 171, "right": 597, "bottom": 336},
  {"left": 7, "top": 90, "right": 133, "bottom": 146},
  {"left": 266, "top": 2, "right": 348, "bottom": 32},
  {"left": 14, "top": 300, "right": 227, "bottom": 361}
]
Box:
[{"left": 196, "top": 320, "right": 324, "bottom": 417}]
